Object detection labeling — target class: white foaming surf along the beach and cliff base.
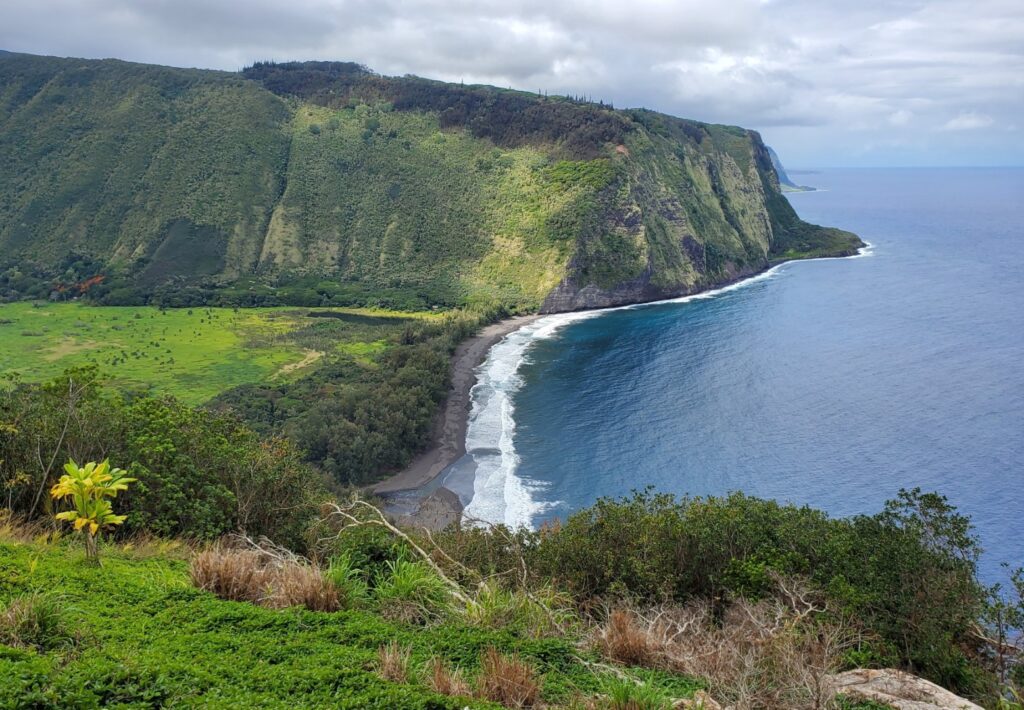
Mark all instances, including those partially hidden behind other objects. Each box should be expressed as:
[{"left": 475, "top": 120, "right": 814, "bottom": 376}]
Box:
[{"left": 464, "top": 244, "right": 872, "bottom": 528}]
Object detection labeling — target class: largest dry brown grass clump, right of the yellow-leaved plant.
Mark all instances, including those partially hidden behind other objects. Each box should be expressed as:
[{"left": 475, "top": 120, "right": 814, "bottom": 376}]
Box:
[{"left": 188, "top": 545, "right": 341, "bottom": 612}]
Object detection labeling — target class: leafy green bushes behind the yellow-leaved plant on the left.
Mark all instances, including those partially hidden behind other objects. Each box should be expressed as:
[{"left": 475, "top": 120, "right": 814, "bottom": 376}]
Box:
[{"left": 0, "top": 368, "right": 325, "bottom": 548}]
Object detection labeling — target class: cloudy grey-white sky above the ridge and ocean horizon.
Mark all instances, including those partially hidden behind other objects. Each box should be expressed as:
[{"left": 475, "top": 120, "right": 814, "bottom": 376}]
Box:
[{"left": 0, "top": 0, "right": 1024, "bottom": 167}]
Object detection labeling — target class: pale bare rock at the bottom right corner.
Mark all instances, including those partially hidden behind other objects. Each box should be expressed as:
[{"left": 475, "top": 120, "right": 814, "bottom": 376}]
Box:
[{"left": 828, "top": 668, "right": 983, "bottom": 710}]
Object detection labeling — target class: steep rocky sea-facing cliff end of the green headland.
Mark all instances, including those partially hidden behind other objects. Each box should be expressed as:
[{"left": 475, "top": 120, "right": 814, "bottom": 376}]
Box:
[{"left": 542, "top": 112, "right": 862, "bottom": 312}]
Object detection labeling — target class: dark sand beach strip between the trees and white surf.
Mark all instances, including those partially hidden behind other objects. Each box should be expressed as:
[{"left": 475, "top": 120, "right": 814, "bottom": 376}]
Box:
[{"left": 370, "top": 316, "right": 540, "bottom": 495}]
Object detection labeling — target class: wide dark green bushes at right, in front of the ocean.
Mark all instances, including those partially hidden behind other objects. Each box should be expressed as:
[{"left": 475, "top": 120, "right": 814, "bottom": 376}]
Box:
[{"left": 437, "top": 491, "right": 1012, "bottom": 699}]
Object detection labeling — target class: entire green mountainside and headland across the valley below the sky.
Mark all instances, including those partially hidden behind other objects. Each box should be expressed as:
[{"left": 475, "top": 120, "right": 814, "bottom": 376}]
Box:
[{"left": 0, "top": 54, "right": 860, "bottom": 311}]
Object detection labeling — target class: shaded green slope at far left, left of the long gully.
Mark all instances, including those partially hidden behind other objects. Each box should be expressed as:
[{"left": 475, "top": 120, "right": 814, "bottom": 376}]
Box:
[{"left": 0, "top": 54, "right": 290, "bottom": 285}]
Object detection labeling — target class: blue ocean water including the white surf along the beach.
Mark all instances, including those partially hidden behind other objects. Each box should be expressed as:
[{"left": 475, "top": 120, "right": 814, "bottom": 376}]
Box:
[{"left": 446, "top": 169, "right": 1024, "bottom": 579}]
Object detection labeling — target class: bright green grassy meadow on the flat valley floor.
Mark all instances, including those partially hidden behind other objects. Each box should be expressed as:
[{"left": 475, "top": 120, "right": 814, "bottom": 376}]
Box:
[{"left": 0, "top": 302, "right": 431, "bottom": 405}]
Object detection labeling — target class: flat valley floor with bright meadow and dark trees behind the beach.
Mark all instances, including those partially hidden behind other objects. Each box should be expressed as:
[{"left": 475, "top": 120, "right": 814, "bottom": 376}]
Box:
[{"left": 0, "top": 303, "right": 471, "bottom": 485}]
